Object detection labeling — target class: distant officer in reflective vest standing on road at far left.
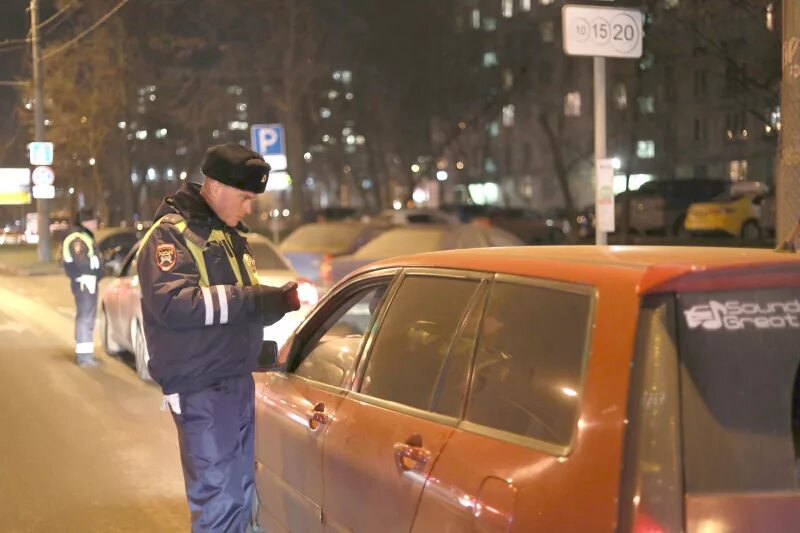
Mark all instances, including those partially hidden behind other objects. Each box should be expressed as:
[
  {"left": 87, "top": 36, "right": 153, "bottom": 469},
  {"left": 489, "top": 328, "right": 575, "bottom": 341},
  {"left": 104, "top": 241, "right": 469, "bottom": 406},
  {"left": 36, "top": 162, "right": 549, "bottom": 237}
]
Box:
[{"left": 61, "top": 207, "right": 102, "bottom": 367}]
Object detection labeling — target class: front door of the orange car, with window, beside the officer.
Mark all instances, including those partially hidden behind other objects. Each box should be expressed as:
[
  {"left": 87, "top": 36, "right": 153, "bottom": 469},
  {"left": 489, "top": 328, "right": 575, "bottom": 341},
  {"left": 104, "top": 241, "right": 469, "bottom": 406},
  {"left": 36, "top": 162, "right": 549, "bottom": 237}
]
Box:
[{"left": 256, "top": 272, "right": 394, "bottom": 532}]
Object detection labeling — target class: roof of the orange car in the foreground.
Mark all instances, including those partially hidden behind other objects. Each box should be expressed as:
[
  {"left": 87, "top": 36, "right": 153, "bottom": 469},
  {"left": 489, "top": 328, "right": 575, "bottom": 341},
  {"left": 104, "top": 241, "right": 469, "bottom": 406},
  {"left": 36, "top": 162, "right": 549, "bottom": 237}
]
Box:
[{"left": 359, "top": 246, "right": 800, "bottom": 294}]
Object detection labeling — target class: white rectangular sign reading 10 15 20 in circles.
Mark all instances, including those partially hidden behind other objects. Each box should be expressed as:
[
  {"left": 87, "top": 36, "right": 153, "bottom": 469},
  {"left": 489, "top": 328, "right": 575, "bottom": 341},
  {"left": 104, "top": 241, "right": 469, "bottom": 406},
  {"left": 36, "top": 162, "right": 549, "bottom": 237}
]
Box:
[{"left": 561, "top": 5, "right": 643, "bottom": 58}]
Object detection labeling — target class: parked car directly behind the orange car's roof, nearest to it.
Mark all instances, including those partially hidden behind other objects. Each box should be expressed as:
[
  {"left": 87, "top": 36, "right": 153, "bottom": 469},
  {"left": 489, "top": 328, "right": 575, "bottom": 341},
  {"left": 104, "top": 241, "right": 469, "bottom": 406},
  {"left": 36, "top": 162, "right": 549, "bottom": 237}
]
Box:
[{"left": 328, "top": 224, "right": 524, "bottom": 288}]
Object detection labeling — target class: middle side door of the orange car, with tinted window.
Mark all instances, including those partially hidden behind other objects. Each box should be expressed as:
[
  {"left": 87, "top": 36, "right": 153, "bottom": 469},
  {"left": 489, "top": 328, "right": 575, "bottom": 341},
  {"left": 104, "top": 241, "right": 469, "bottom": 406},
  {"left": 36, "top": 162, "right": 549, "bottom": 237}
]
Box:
[{"left": 323, "top": 271, "right": 486, "bottom": 532}]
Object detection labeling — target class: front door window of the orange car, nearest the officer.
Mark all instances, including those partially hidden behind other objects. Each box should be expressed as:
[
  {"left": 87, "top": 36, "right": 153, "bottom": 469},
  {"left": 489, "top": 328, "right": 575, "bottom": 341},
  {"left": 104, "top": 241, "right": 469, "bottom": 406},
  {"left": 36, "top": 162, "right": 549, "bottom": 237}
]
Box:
[{"left": 294, "top": 280, "right": 389, "bottom": 387}]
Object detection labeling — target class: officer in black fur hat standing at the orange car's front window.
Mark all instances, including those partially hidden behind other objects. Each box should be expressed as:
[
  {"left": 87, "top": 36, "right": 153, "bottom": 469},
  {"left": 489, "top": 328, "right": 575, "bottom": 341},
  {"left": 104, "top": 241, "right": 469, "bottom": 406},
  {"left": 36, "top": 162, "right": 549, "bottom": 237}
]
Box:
[{"left": 137, "top": 144, "right": 300, "bottom": 532}]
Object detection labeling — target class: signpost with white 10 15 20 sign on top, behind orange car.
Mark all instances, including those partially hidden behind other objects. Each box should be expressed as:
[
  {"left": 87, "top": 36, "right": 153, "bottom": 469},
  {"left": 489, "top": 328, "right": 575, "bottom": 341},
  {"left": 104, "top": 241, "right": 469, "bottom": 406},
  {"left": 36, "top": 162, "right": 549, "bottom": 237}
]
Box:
[{"left": 561, "top": 5, "right": 643, "bottom": 245}]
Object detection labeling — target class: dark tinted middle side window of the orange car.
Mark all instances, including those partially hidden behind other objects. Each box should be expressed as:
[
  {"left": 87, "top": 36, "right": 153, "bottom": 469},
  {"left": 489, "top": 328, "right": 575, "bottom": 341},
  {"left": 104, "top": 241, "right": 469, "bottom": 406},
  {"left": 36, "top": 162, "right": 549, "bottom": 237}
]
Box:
[{"left": 360, "top": 276, "right": 480, "bottom": 416}]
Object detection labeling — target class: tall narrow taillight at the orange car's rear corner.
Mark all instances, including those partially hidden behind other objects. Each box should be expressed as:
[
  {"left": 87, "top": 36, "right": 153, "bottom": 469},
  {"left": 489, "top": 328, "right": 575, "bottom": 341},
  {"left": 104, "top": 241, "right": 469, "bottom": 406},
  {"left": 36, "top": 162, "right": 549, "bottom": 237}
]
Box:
[{"left": 618, "top": 296, "right": 683, "bottom": 533}]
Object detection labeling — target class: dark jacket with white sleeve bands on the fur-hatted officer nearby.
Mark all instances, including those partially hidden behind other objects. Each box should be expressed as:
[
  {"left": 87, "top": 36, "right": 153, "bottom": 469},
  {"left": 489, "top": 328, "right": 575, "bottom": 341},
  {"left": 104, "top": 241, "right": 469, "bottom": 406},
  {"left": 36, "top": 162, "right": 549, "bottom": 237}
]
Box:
[{"left": 137, "top": 183, "right": 283, "bottom": 394}]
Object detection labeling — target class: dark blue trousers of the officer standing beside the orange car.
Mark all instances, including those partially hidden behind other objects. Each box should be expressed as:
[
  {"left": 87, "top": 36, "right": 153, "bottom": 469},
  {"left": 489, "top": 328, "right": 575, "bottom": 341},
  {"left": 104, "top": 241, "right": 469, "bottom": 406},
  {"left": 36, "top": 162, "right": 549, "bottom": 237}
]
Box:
[{"left": 172, "top": 374, "right": 255, "bottom": 533}]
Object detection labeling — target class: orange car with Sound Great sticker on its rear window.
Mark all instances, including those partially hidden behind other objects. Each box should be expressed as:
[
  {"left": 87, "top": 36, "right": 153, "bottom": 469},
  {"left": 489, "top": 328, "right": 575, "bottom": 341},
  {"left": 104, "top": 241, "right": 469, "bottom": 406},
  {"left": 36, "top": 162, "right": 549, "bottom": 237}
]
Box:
[{"left": 256, "top": 247, "right": 800, "bottom": 533}]
